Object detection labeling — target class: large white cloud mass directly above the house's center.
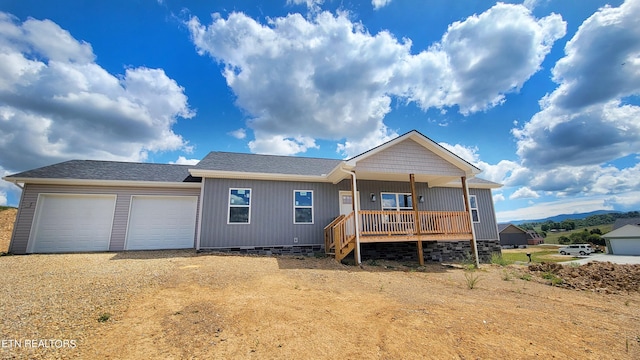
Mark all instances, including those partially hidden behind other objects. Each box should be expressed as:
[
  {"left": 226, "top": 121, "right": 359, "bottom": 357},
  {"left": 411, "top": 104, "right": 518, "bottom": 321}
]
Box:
[{"left": 187, "top": 0, "right": 565, "bottom": 156}]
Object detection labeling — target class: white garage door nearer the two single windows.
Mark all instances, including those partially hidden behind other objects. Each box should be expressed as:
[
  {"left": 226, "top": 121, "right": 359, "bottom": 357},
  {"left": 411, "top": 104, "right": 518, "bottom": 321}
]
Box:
[{"left": 126, "top": 196, "right": 198, "bottom": 250}]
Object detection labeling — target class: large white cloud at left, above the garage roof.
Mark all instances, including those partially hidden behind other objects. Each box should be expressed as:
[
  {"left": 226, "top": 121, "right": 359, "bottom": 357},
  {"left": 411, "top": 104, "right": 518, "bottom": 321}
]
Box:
[{"left": 0, "top": 13, "right": 194, "bottom": 171}]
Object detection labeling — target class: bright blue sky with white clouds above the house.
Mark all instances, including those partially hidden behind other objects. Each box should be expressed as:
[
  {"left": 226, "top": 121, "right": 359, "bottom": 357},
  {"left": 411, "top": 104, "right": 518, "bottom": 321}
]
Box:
[{"left": 0, "top": 0, "right": 640, "bottom": 221}]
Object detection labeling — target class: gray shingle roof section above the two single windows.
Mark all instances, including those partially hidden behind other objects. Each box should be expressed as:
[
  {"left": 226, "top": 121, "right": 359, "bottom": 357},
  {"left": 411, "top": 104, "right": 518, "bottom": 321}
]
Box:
[{"left": 192, "top": 151, "right": 342, "bottom": 176}]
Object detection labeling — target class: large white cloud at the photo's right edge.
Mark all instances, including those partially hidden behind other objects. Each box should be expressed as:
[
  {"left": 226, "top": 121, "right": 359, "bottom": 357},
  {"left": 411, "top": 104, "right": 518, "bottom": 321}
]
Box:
[{"left": 513, "top": 0, "right": 640, "bottom": 168}]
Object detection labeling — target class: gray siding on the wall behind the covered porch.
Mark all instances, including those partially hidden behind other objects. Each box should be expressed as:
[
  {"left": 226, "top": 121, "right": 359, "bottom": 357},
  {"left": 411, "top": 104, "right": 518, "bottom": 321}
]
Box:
[{"left": 338, "top": 179, "right": 499, "bottom": 240}]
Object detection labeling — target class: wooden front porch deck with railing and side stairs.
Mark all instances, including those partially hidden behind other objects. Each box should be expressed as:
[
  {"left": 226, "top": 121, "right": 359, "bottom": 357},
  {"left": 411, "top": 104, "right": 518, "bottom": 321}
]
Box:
[{"left": 324, "top": 210, "right": 473, "bottom": 264}]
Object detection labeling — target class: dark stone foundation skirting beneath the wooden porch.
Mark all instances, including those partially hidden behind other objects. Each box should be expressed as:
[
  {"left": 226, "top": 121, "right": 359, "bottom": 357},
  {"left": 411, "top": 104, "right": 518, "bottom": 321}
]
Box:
[{"left": 360, "top": 240, "right": 501, "bottom": 263}]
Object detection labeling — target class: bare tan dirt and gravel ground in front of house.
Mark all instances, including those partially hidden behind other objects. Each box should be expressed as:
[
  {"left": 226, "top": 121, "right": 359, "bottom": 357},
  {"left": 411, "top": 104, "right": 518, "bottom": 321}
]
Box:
[{"left": 0, "top": 213, "right": 640, "bottom": 359}]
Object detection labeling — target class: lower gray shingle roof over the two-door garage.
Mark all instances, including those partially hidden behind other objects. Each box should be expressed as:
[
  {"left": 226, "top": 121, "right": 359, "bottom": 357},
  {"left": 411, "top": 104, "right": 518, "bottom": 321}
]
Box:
[{"left": 7, "top": 160, "right": 201, "bottom": 182}]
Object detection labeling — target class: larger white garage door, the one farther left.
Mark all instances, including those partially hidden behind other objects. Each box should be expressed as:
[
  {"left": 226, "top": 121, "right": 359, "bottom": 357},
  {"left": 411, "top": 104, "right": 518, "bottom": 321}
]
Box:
[{"left": 27, "top": 194, "right": 116, "bottom": 253}]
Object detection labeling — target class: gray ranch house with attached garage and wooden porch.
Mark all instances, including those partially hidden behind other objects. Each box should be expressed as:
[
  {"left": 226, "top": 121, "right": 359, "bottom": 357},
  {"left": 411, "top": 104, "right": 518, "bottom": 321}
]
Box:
[{"left": 3, "top": 130, "right": 501, "bottom": 263}]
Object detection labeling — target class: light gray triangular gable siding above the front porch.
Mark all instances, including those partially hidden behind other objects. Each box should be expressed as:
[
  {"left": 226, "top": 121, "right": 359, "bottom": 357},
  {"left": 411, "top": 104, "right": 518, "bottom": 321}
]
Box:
[{"left": 356, "top": 139, "right": 464, "bottom": 176}]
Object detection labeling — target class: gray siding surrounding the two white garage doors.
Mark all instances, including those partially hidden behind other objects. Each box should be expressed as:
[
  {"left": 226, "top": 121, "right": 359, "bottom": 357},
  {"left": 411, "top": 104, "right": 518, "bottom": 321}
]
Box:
[{"left": 10, "top": 184, "right": 200, "bottom": 254}]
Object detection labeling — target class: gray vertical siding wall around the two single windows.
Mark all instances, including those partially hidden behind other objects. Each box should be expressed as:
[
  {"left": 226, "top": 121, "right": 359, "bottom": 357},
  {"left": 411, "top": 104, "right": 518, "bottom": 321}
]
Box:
[{"left": 200, "top": 178, "right": 340, "bottom": 249}]
